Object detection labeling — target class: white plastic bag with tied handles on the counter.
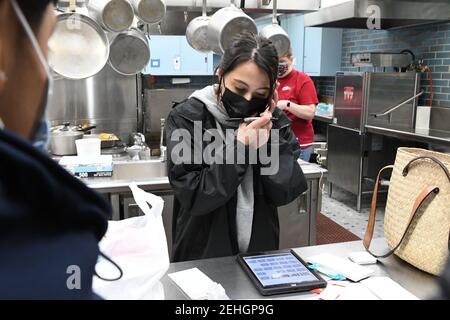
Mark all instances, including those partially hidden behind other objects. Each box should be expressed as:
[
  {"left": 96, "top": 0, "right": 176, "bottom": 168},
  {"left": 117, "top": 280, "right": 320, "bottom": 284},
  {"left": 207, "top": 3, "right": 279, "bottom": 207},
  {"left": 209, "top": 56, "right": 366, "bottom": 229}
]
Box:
[{"left": 93, "top": 184, "right": 169, "bottom": 300}]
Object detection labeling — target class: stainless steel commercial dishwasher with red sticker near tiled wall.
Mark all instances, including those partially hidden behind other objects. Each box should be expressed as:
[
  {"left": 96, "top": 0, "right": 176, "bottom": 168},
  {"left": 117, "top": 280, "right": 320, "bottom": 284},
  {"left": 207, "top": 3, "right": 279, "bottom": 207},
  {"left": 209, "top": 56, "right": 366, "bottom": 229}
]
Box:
[{"left": 327, "top": 72, "right": 419, "bottom": 211}]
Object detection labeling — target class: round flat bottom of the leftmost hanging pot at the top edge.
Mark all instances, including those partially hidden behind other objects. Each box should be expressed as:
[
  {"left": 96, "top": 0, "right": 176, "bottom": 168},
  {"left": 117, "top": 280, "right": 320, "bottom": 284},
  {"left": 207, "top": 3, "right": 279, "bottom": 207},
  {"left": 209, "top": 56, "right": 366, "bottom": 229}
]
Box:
[{"left": 102, "top": 0, "right": 134, "bottom": 32}]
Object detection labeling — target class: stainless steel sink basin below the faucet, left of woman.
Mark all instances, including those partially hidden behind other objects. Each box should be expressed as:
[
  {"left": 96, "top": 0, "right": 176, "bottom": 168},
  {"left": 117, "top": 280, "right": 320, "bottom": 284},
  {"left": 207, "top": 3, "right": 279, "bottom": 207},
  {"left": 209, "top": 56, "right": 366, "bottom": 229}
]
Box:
[{"left": 113, "top": 159, "right": 167, "bottom": 181}]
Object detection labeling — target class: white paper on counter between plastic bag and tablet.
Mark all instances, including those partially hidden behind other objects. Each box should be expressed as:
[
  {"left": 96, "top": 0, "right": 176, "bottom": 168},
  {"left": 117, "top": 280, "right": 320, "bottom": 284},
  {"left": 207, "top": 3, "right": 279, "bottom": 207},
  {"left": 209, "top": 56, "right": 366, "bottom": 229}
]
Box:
[{"left": 169, "top": 268, "right": 229, "bottom": 300}]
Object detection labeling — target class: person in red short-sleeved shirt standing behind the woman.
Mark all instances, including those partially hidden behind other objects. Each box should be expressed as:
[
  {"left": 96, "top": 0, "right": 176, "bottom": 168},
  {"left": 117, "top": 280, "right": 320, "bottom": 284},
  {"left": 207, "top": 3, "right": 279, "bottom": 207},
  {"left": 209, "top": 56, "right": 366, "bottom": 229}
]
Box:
[{"left": 277, "top": 49, "right": 319, "bottom": 161}]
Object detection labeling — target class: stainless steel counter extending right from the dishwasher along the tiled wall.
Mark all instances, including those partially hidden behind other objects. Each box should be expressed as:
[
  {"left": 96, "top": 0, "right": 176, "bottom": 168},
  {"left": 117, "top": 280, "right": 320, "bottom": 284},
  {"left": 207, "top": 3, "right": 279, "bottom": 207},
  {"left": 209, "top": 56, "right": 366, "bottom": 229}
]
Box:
[{"left": 366, "top": 125, "right": 450, "bottom": 146}]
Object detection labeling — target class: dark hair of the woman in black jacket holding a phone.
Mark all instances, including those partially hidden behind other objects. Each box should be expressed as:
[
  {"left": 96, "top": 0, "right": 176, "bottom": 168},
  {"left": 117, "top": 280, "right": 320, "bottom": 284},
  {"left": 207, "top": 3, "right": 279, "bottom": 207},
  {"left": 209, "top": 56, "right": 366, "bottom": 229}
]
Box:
[{"left": 216, "top": 32, "right": 278, "bottom": 101}]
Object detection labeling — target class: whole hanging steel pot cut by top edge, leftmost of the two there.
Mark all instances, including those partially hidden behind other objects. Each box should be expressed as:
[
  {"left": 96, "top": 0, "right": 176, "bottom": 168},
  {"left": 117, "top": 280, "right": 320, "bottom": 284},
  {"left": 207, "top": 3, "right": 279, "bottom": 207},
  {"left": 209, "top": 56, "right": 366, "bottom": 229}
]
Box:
[{"left": 87, "top": 0, "right": 134, "bottom": 32}]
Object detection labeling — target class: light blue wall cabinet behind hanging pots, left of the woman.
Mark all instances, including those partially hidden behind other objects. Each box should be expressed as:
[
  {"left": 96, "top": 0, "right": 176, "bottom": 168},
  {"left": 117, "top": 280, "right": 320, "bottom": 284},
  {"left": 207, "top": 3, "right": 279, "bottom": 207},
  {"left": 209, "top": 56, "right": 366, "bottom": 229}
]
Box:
[{"left": 143, "top": 35, "right": 213, "bottom": 76}]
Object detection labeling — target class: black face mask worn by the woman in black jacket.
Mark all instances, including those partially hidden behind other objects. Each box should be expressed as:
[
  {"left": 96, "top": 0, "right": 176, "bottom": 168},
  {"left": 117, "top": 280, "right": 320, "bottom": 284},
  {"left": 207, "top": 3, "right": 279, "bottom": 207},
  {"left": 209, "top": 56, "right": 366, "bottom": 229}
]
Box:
[{"left": 222, "top": 87, "right": 267, "bottom": 118}]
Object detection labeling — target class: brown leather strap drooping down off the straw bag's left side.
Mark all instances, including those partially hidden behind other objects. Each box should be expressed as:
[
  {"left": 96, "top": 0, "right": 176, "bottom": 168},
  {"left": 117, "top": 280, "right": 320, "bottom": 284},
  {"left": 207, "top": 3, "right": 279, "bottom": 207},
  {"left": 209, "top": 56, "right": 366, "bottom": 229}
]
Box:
[{"left": 363, "top": 166, "right": 440, "bottom": 258}]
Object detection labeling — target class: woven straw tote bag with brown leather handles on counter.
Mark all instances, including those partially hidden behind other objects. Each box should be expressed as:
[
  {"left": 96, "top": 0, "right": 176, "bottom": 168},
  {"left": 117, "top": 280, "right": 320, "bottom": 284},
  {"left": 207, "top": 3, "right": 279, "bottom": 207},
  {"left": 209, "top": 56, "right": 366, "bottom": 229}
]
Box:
[{"left": 364, "top": 148, "right": 450, "bottom": 275}]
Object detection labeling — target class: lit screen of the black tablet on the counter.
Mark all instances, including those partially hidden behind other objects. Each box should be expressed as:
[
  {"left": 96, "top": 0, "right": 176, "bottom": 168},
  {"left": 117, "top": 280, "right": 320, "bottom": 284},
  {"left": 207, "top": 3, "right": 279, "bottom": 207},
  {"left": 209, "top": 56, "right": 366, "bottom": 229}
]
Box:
[{"left": 243, "top": 253, "right": 319, "bottom": 287}]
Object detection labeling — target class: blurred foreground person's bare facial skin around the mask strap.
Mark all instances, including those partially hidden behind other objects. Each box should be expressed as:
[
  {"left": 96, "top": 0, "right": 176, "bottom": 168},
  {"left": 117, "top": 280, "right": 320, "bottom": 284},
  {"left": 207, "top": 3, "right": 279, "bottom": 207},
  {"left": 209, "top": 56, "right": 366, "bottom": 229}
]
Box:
[{"left": 0, "top": 0, "right": 56, "bottom": 139}]
